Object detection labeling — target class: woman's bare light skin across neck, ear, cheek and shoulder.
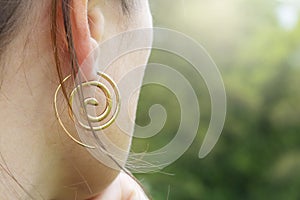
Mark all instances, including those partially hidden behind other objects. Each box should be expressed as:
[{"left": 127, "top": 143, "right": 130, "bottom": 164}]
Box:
[{"left": 0, "top": 0, "right": 152, "bottom": 200}]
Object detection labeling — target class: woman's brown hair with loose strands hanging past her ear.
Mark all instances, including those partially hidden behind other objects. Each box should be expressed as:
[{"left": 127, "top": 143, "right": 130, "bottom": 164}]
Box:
[{"left": 0, "top": 0, "right": 149, "bottom": 199}]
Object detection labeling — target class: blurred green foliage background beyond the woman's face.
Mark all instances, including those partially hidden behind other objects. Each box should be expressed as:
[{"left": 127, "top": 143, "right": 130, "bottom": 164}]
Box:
[{"left": 132, "top": 0, "right": 300, "bottom": 200}]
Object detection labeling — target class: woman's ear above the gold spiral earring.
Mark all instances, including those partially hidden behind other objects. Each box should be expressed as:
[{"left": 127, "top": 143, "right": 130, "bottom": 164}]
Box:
[{"left": 70, "top": 0, "right": 104, "bottom": 76}]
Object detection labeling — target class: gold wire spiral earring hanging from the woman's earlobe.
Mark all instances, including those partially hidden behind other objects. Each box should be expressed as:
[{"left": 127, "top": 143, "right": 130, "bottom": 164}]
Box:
[{"left": 54, "top": 72, "right": 120, "bottom": 149}]
